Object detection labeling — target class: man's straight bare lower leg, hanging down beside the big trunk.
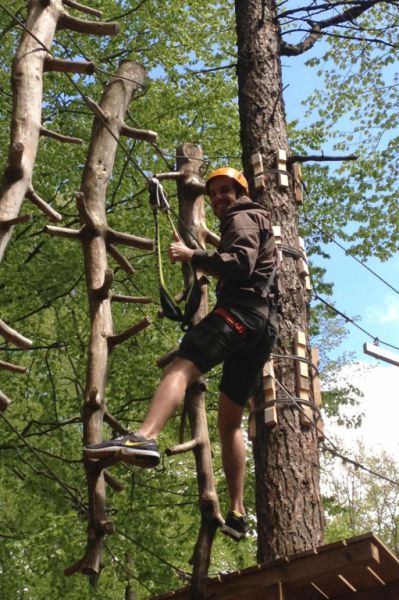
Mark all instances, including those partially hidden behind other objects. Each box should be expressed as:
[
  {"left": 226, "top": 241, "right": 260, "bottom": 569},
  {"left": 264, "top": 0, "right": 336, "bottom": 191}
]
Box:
[{"left": 218, "top": 392, "right": 246, "bottom": 515}]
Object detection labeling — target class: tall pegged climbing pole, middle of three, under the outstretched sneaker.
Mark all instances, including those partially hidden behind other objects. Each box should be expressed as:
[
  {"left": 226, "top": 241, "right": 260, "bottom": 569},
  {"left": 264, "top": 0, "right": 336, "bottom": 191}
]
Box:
[{"left": 45, "top": 62, "right": 156, "bottom": 576}]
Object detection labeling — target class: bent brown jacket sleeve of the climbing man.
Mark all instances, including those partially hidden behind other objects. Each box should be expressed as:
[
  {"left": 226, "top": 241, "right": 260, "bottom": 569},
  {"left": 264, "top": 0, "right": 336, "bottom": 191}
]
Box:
[{"left": 191, "top": 214, "right": 260, "bottom": 281}]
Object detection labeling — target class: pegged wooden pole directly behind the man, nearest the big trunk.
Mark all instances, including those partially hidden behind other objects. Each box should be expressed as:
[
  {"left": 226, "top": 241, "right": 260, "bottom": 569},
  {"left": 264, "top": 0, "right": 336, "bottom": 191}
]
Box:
[{"left": 157, "top": 143, "right": 223, "bottom": 600}]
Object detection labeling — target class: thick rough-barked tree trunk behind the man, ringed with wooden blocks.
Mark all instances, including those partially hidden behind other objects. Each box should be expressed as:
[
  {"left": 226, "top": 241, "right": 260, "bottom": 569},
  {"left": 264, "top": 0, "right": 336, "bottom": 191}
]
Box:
[{"left": 235, "top": 0, "right": 323, "bottom": 562}]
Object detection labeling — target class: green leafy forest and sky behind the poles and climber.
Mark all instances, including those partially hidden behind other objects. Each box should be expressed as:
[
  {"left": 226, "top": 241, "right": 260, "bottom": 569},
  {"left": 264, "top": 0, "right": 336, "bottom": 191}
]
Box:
[{"left": 0, "top": 0, "right": 399, "bottom": 600}]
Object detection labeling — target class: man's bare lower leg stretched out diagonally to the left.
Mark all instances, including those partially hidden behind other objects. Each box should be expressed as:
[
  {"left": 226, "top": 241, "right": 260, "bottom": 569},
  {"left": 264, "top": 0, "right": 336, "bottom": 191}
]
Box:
[{"left": 137, "top": 358, "right": 201, "bottom": 439}]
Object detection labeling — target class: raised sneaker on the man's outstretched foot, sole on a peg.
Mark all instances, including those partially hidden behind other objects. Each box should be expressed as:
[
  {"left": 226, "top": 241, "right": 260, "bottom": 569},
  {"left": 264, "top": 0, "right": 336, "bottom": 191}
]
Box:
[{"left": 83, "top": 433, "right": 161, "bottom": 467}]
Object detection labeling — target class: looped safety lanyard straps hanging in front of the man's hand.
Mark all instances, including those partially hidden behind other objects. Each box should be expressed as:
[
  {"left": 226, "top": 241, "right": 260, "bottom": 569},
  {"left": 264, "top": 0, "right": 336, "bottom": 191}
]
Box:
[{"left": 148, "top": 177, "right": 201, "bottom": 331}]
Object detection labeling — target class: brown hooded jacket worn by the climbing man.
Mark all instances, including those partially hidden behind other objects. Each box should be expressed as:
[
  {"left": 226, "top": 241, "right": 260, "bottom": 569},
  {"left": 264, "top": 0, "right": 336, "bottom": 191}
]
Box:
[{"left": 192, "top": 196, "right": 277, "bottom": 314}]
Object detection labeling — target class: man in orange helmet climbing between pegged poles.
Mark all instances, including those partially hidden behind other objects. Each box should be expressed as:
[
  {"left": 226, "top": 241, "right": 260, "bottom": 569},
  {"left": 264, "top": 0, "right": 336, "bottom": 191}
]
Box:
[{"left": 84, "top": 167, "right": 277, "bottom": 541}]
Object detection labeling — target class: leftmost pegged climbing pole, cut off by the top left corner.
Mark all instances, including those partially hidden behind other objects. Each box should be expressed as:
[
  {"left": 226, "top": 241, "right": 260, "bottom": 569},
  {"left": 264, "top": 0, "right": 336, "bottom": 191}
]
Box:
[{"left": 0, "top": 0, "right": 118, "bottom": 412}]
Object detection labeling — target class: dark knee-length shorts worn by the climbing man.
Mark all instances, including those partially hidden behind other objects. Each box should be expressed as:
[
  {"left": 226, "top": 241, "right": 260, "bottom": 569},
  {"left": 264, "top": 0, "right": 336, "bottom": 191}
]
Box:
[{"left": 178, "top": 306, "right": 277, "bottom": 406}]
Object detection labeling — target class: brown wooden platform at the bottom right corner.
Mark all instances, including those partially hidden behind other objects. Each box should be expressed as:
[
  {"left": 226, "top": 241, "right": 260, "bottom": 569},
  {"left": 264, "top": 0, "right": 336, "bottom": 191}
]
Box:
[{"left": 151, "top": 533, "right": 399, "bottom": 600}]
